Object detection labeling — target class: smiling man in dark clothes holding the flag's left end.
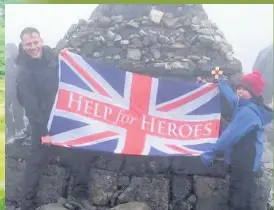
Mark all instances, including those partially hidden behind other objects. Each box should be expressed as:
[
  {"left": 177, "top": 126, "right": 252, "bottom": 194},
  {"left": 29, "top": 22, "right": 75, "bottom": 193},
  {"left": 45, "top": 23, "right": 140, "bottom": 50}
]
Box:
[{"left": 16, "top": 27, "right": 94, "bottom": 210}]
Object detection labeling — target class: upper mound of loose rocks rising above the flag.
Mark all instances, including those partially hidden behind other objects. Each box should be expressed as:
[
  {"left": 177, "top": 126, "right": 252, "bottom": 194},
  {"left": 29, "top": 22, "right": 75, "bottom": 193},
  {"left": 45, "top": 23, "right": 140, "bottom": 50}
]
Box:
[{"left": 57, "top": 4, "right": 242, "bottom": 79}]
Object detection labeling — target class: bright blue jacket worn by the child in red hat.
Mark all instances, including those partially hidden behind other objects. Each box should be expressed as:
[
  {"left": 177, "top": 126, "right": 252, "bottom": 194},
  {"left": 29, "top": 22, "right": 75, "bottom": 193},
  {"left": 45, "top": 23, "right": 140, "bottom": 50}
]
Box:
[{"left": 201, "top": 79, "right": 272, "bottom": 172}]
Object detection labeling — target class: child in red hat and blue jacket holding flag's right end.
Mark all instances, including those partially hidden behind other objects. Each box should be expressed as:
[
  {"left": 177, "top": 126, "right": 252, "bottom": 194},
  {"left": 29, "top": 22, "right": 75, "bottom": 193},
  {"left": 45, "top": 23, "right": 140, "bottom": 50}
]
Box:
[{"left": 201, "top": 70, "right": 272, "bottom": 210}]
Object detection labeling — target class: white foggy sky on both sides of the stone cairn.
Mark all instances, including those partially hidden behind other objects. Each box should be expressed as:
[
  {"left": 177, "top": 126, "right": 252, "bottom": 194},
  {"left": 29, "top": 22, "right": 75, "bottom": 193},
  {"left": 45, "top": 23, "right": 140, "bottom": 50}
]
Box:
[{"left": 5, "top": 4, "right": 273, "bottom": 72}]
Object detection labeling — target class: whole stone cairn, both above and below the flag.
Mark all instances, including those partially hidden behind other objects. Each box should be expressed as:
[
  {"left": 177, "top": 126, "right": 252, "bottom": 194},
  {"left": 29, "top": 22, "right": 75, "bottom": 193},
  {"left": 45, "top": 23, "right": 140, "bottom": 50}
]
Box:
[{"left": 6, "top": 5, "right": 269, "bottom": 210}]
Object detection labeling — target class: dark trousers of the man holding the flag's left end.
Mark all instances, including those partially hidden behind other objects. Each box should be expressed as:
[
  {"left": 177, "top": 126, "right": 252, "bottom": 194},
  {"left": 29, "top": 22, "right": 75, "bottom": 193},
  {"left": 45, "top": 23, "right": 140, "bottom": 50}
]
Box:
[{"left": 21, "top": 127, "right": 89, "bottom": 210}]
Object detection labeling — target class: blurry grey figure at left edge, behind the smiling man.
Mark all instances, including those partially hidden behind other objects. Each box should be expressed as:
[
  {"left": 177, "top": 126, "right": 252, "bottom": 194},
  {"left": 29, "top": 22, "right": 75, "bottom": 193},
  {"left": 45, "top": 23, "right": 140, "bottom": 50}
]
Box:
[{"left": 5, "top": 43, "right": 25, "bottom": 139}]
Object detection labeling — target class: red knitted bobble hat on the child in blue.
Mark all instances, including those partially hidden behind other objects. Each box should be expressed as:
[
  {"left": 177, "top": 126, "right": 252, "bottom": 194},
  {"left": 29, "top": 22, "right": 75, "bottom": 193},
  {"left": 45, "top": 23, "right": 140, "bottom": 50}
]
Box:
[{"left": 238, "top": 70, "right": 265, "bottom": 97}]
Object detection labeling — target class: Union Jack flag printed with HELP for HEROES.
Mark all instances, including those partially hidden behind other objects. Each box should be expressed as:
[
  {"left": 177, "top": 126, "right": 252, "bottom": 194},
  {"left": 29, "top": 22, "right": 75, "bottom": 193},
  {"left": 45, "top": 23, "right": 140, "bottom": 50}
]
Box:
[{"left": 45, "top": 51, "right": 220, "bottom": 156}]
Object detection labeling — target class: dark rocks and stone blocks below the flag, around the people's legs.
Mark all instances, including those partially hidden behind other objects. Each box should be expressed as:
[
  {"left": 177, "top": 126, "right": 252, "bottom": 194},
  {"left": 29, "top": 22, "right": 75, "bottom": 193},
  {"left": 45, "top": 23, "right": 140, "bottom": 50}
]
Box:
[{"left": 6, "top": 136, "right": 271, "bottom": 210}]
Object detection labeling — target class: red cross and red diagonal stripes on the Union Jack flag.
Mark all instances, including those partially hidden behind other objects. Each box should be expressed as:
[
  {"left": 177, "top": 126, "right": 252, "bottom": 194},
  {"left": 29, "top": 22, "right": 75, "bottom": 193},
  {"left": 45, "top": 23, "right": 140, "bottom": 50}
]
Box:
[{"left": 56, "top": 51, "right": 219, "bottom": 155}]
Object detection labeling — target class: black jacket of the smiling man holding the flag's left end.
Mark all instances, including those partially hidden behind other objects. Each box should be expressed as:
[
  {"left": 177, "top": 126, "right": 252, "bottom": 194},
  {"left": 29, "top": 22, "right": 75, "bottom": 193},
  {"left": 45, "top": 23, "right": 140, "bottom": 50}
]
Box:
[{"left": 16, "top": 45, "right": 59, "bottom": 136}]
